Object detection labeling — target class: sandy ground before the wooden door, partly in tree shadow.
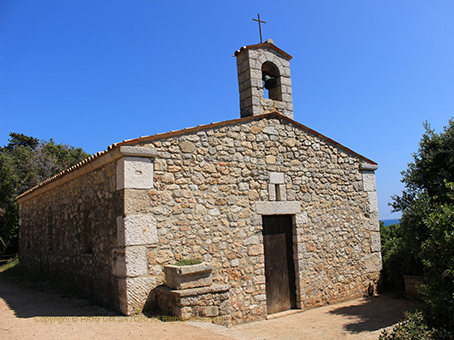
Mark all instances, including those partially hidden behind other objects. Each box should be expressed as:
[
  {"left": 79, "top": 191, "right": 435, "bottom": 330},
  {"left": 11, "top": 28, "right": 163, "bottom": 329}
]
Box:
[{"left": 235, "top": 294, "right": 420, "bottom": 340}]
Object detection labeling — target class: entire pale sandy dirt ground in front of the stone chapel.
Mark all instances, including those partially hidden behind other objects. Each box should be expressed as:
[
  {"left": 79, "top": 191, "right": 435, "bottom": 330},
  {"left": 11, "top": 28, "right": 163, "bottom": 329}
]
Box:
[{"left": 0, "top": 274, "right": 424, "bottom": 340}]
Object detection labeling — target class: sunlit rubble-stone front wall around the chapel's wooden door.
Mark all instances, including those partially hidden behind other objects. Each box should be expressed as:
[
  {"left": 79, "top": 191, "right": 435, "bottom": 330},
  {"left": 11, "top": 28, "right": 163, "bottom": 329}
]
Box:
[{"left": 125, "top": 116, "right": 381, "bottom": 322}]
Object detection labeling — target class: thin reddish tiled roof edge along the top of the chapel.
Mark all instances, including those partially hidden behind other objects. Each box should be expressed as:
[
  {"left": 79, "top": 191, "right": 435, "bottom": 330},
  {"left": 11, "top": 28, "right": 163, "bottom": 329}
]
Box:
[{"left": 16, "top": 111, "right": 377, "bottom": 199}]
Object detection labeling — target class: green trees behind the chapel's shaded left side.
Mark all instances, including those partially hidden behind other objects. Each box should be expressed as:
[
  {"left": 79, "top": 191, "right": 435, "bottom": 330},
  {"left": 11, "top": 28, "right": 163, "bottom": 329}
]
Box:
[{"left": 0, "top": 132, "right": 89, "bottom": 252}]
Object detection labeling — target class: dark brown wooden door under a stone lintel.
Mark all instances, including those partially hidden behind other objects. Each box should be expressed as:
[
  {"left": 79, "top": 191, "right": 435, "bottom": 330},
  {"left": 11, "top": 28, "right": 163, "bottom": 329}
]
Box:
[{"left": 263, "top": 215, "right": 296, "bottom": 314}]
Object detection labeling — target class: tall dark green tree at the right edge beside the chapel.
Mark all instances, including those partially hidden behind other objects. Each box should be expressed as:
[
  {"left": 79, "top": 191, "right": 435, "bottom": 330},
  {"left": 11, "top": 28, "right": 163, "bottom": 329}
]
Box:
[{"left": 384, "top": 119, "right": 454, "bottom": 332}]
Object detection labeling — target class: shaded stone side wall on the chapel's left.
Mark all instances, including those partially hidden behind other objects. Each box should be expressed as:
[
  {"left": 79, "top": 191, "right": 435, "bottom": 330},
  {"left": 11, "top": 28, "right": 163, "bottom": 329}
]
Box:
[{"left": 19, "top": 162, "right": 123, "bottom": 309}]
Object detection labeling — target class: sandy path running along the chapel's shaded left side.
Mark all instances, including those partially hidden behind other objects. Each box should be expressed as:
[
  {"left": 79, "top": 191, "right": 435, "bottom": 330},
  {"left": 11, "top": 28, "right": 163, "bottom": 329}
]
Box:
[{"left": 0, "top": 278, "right": 238, "bottom": 340}]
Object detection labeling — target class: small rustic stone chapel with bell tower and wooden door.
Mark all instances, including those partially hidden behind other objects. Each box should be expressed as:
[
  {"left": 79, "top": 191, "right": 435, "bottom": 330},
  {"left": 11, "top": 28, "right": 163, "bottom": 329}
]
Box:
[{"left": 17, "top": 40, "right": 382, "bottom": 324}]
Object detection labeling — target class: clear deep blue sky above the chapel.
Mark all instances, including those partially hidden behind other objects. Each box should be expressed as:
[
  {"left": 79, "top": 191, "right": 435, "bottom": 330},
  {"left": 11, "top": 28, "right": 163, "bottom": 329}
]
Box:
[{"left": 0, "top": 0, "right": 454, "bottom": 219}]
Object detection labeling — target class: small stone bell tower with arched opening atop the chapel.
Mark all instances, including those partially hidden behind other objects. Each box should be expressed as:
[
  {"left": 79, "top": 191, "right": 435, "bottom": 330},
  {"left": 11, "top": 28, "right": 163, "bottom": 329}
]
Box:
[{"left": 234, "top": 39, "right": 293, "bottom": 119}]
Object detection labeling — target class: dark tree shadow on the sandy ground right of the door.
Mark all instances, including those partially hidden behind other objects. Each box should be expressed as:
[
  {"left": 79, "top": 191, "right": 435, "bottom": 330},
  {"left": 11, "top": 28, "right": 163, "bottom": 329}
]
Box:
[{"left": 329, "top": 293, "right": 423, "bottom": 334}]
